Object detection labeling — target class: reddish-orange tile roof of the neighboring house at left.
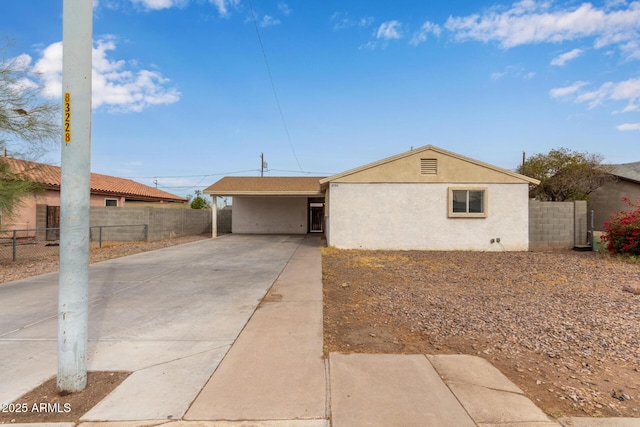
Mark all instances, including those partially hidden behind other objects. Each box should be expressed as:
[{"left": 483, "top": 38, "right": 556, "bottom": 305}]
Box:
[{"left": 0, "top": 157, "right": 187, "bottom": 202}]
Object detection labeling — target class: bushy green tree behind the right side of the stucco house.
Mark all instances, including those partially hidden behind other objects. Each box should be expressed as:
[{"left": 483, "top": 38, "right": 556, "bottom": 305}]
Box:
[{"left": 517, "top": 148, "right": 614, "bottom": 202}]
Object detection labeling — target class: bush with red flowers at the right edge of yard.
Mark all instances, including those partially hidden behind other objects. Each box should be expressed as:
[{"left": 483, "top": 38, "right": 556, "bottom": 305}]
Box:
[{"left": 601, "top": 197, "right": 640, "bottom": 256}]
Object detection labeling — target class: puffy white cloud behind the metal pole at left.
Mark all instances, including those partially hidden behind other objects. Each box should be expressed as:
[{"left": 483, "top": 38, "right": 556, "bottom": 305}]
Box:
[{"left": 33, "top": 38, "right": 180, "bottom": 112}]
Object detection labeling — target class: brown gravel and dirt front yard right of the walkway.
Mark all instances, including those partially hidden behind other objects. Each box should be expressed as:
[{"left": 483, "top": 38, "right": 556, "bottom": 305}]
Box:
[{"left": 323, "top": 248, "right": 640, "bottom": 417}]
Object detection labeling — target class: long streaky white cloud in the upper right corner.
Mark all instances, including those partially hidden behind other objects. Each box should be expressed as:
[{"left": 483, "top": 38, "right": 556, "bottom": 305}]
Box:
[{"left": 445, "top": 0, "right": 640, "bottom": 58}]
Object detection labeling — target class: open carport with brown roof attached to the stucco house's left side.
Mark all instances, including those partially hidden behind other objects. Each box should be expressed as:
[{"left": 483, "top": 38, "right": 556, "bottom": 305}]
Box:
[{"left": 204, "top": 176, "right": 325, "bottom": 236}]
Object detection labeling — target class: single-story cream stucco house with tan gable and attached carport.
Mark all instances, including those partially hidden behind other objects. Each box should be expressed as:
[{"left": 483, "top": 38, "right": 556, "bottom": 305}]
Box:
[{"left": 204, "top": 145, "right": 539, "bottom": 251}]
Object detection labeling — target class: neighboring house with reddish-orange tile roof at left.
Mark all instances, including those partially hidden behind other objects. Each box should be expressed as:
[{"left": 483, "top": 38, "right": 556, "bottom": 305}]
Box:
[{"left": 0, "top": 157, "right": 188, "bottom": 230}]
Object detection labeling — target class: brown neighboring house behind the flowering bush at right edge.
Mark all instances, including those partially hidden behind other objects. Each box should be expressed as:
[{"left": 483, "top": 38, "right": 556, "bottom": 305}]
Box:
[{"left": 589, "top": 162, "right": 640, "bottom": 230}]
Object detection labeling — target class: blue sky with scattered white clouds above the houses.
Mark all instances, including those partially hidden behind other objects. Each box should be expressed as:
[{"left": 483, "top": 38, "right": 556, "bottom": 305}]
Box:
[{"left": 0, "top": 0, "right": 640, "bottom": 199}]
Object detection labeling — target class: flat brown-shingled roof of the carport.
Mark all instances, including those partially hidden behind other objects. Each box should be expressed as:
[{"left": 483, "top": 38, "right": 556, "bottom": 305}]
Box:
[{"left": 204, "top": 176, "right": 324, "bottom": 196}]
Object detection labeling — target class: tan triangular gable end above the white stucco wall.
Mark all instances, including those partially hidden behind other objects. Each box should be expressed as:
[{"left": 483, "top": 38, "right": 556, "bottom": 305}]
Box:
[{"left": 320, "top": 145, "right": 540, "bottom": 185}]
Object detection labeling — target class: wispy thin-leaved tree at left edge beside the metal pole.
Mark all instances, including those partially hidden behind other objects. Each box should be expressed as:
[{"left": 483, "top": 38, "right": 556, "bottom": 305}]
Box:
[{"left": 0, "top": 38, "right": 62, "bottom": 226}]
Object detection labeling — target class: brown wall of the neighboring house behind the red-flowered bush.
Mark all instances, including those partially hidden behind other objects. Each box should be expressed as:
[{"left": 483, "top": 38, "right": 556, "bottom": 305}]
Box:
[{"left": 589, "top": 180, "right": 640, "bottom": 234}]
